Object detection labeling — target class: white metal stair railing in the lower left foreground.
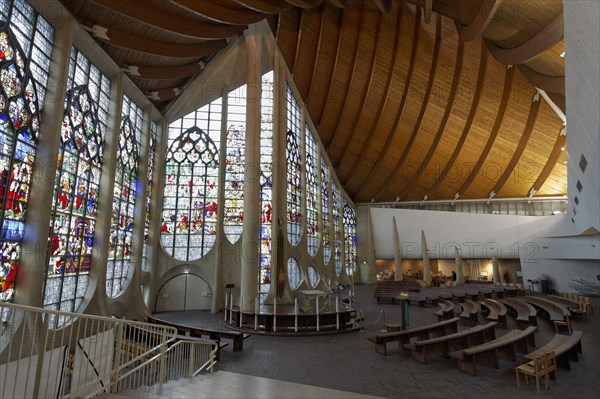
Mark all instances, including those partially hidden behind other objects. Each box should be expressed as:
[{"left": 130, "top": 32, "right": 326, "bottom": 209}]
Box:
[{"left": 0, "top": 303, "right": 218, "bottom": 399}]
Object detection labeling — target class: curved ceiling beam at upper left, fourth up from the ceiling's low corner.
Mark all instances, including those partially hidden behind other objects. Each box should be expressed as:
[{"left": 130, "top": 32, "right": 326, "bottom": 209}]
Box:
[{"left": 93, "top": 0, "right": 246, "bottom": 39}]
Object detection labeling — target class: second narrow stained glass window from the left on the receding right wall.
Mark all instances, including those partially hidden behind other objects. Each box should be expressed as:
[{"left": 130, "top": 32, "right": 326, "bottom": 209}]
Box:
[{"left": 306, "top": 125, "right": 319, "bottom": 256}]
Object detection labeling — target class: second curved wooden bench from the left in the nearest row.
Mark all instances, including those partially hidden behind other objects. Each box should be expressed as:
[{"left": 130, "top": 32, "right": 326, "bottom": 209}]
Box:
[{"left": 404, "top": 321, "right": 497, "bottom": 364}]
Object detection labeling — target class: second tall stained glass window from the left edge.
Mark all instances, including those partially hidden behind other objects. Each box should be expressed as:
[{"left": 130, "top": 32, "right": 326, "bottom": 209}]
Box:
[{"left": 44, "top": 47, "right": 110, "bottom": 316}]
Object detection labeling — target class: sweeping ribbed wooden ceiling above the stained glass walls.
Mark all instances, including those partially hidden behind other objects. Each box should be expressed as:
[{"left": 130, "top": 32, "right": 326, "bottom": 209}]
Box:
[{"left": 61, "top": 0, "right": 567, "bottom": 202}]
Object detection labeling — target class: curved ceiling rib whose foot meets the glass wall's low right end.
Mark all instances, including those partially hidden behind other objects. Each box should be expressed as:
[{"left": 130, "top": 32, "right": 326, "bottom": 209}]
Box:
[{"left": 353, "top": 8, "right": 421, "bottom": 198}]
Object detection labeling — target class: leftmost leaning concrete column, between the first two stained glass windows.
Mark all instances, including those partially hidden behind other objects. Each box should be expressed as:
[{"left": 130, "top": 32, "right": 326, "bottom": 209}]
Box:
[{"left": 15, "top": 18, "right": 74, "bottom": 307}]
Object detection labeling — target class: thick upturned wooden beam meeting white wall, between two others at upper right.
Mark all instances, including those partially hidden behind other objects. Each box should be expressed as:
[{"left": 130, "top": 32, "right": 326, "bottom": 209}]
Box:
[{"left": 486, "top": 12, "right": 564, "bottom": 65}]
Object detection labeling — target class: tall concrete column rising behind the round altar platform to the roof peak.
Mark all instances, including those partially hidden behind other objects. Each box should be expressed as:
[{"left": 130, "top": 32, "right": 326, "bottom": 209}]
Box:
[{"left": 240, "top": 27, "right": 262, "bottom": 311}]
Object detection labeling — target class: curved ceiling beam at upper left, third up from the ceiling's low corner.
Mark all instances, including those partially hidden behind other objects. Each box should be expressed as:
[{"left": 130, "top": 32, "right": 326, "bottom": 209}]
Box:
[{"left": 85, "top": 25, "right": 227, "bottom": 58}]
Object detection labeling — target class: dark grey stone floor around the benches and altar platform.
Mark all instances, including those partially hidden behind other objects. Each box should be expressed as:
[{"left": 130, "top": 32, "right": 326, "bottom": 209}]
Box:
[{"left": 151, "top": 285, "right": 600, "bottom": 399}]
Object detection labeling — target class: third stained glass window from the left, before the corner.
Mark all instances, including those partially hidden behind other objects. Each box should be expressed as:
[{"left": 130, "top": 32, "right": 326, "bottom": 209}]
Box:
[{"left": 106, "top": 96, "right": 143, "bottom": 298}]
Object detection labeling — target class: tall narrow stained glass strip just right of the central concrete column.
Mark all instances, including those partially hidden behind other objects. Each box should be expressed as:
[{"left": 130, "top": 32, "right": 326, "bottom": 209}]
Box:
[{"left": 258, "top": 71, "right": 274, "bottom": 304}]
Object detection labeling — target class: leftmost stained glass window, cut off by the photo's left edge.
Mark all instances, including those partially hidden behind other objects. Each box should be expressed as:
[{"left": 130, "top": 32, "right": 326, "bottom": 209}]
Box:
[{"left": 0, "top": 0, "right": 54, "bottom": 302}]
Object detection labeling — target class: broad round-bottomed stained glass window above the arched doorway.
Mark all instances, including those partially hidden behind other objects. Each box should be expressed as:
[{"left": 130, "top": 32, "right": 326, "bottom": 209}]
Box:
[{"left": 160, "top": 98, "right": 221, "bottom": 261}]
